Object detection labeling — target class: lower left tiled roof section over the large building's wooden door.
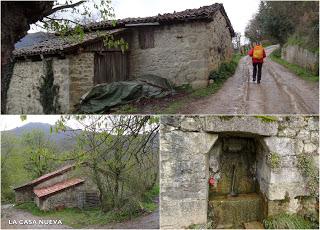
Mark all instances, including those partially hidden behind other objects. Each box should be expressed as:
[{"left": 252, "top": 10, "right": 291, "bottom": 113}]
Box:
[{"left": 13, "top": 29, "right": 125, "bottom": 57}]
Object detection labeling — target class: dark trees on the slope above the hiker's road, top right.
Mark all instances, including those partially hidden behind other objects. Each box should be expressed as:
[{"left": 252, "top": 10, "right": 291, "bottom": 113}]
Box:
[{"left": 245, "top": 1, "right": 319, "bottom": 51}]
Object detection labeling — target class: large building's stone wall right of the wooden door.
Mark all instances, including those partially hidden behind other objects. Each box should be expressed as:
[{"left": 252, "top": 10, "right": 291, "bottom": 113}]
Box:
[{"left": 129, "top": 12, "right": 232, "bottom": 88}]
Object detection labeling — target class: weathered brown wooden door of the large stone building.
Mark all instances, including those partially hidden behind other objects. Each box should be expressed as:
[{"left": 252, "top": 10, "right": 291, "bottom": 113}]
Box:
[{"left": 94, "top": 51, "right": 129, "bottom": 85}]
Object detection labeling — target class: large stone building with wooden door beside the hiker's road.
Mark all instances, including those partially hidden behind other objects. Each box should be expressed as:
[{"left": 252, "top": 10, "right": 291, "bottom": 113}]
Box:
[{"left": 3, "top": 4, "right": 234, "bottom": 114}]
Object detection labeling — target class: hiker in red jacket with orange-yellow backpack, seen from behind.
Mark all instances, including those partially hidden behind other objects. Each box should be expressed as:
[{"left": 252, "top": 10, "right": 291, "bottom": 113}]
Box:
[{"left": 248, "top": 43, "right": 266, "bottom": 84}]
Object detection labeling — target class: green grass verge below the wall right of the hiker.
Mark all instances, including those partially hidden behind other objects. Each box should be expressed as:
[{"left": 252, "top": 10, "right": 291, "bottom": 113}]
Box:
[{"left": 270, "top": 48, "right": 319, "bottom": 82}]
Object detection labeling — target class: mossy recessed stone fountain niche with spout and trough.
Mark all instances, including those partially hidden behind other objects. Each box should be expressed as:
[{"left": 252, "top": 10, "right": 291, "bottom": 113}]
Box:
[{"left": 208, "top": 134, "right": 264, "bottom": 229}]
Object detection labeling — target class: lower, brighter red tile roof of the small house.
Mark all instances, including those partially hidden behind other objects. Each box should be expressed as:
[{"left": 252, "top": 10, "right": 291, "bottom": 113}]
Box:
[{"left": 33, "top": 178, "right": 84, "bottom": 198}]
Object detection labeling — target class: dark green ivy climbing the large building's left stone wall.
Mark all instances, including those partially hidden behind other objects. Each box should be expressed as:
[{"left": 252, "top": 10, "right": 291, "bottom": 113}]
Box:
[{"left": 38, "top": 59, "right": 60, "bottom": 114}]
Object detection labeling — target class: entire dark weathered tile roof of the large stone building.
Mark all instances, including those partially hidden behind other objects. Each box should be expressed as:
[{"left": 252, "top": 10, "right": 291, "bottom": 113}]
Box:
[{"left": 13, "top": 3, "right": 235, "bottom": 57}]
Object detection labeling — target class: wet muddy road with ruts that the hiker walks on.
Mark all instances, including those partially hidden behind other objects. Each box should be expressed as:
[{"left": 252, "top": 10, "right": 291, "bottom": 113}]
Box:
[{"left": 179, "top": 46, "right": 319, "bottom": 114}]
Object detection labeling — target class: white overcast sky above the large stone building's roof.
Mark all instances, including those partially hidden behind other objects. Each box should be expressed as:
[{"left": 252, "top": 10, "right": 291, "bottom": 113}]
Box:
[{"left": 29, "top": 0, "right": 260, "bottom": 39}]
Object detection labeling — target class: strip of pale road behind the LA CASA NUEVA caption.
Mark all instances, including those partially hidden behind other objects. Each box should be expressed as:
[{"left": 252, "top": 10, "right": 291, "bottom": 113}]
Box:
[{"left": 1, "top": 204, "right": 70, "bottom": 229}]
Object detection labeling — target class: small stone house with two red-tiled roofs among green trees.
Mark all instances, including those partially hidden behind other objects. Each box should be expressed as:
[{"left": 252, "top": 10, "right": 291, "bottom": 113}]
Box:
[{"left": 14, "top": 164, "right": 99, "bottom": 210}]
